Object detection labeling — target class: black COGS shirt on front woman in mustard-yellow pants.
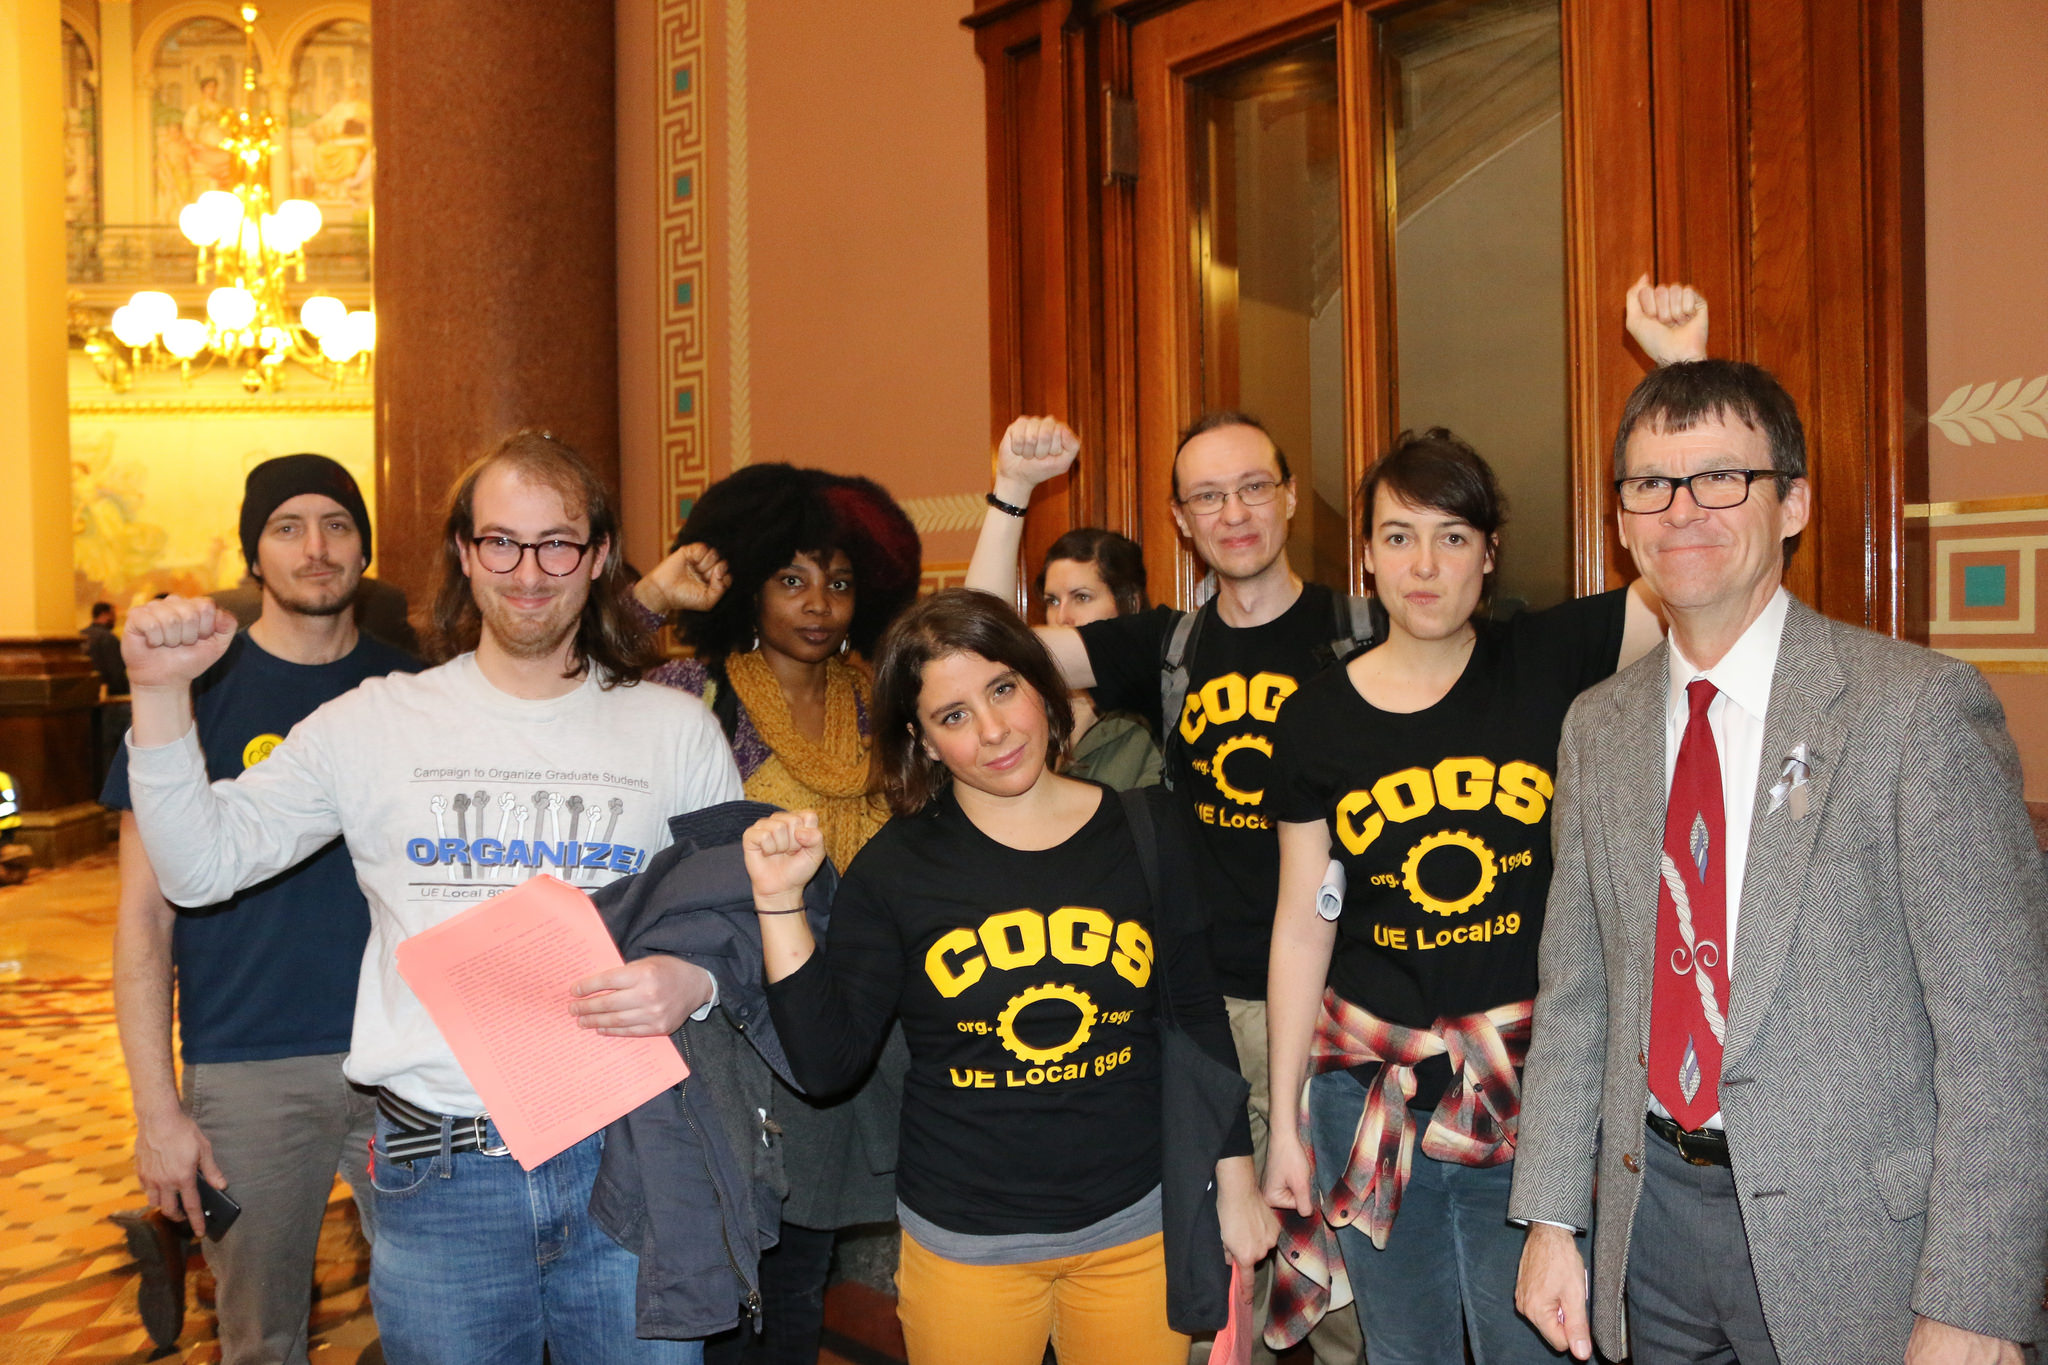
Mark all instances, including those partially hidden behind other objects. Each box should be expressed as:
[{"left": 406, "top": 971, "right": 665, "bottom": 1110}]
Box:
[{"left": 768, "top": 788, "right": 1249, "bottom": 1234}]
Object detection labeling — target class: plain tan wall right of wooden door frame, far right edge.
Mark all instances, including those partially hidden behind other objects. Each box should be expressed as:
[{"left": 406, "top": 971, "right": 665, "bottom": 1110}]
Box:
[{"left": 1925, "top": 0, "right": 2048, "bottom": 802}]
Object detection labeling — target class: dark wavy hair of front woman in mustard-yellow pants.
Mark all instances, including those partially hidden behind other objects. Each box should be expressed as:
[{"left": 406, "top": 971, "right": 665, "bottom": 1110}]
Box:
[{"left": 874, "top": 587, "right": 1073, "bottom": 814}]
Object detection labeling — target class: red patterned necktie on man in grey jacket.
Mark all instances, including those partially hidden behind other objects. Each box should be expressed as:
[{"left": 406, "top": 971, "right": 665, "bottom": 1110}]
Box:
[{"left": 1649, "top": 677, "right": 1729, "bottom": 1130}]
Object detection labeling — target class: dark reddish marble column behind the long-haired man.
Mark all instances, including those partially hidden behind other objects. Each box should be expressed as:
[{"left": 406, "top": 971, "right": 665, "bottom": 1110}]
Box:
[{"left": 371, "top": 0, "right": 618, "bottom": 614}]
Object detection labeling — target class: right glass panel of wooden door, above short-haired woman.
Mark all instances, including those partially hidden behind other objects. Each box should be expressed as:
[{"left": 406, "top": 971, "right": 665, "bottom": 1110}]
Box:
[{"left": 1374, "top": 0, "right": 1573, "bottom": 614}]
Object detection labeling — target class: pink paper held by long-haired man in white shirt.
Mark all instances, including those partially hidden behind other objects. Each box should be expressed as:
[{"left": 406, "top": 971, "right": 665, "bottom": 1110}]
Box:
[{"left": 397, "top": 874, "right": 690, "bottom": 1171}]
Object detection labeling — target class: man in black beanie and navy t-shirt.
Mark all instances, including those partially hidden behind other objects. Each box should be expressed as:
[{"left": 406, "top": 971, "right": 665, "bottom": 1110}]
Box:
[{"left": 100, "top": 454, "right": 420, "bottom": 1365}]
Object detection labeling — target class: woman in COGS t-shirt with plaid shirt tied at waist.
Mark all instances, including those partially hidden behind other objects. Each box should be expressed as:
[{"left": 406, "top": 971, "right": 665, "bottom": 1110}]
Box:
[{"left": 1266, "top": 437, "right": 1659, "bottom": 1365}]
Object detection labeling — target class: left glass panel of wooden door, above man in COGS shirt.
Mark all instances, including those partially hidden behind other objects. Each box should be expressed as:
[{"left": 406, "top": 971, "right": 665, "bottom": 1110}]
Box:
[{"left": 1188, "top": 33, "right": 1350, "bottom": 585}]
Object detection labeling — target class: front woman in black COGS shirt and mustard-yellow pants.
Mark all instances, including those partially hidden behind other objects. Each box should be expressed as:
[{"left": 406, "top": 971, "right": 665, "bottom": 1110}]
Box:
[{"left": 745, "top": 589, "right": 1274, "bottom": 1365}]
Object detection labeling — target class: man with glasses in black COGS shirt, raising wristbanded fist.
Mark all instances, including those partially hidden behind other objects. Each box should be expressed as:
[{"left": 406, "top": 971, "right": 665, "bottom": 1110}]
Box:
[{"left": 967, "top": 411, "right": 1370, "bottom": 1365}]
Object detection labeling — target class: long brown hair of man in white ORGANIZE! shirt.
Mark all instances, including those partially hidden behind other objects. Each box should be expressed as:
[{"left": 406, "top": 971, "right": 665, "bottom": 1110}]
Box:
[{"left": 432, "top": 432, "right": 655, "bottom": 688}]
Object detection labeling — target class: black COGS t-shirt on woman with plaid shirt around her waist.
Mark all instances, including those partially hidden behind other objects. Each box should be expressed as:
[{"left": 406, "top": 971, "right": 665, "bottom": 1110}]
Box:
[{"left": 1274, "top": 589, "right": 1628, "bottom": 1107}]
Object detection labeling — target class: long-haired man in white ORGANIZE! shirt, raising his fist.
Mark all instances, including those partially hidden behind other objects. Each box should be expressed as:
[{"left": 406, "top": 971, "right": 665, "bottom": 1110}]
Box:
[{"left": 123, "top": 432, "right": 739, "bottom": 1365}]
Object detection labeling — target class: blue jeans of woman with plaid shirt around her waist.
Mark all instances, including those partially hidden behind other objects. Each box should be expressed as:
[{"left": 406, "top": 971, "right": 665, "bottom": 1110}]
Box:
[{"left": 1309, "top": 1070, "right": 1561, "bottom": 1365}]
